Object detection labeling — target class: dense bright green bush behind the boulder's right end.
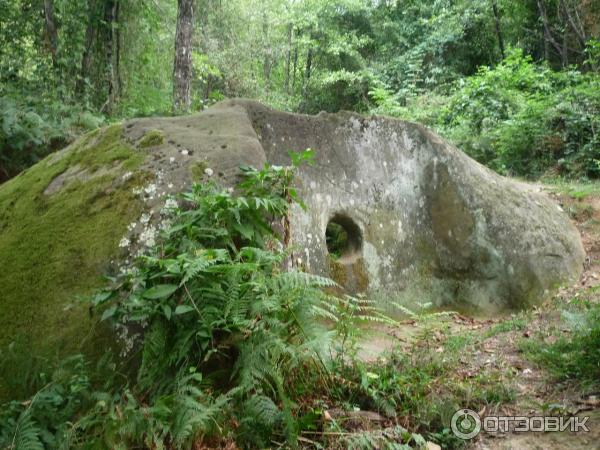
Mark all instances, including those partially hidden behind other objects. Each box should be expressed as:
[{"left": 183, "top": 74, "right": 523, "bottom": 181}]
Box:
[{"left": 441, "top": 51, "right": 600, "bottom": 177}]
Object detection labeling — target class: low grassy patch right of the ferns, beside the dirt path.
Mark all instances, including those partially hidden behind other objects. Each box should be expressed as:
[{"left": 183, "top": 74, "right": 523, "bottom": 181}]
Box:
[{"left": 318, "top": 304, "right": 515, "bottom": 449}]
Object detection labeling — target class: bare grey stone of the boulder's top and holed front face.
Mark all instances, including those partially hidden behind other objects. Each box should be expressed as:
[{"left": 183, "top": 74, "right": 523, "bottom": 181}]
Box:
[{"left": 52, "top": 100, "right": 584, "bottom": 312}]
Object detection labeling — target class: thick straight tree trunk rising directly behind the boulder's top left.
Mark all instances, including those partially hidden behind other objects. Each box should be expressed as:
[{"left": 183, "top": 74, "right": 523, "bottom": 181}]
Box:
[{"left": 173, "top": 0, "right": 194, "bottom": 113}]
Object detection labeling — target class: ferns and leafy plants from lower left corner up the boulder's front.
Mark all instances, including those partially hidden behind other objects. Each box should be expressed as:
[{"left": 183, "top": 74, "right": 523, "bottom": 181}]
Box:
[{"left": 0, "top": 154, "right": 344, "bottom": 448}]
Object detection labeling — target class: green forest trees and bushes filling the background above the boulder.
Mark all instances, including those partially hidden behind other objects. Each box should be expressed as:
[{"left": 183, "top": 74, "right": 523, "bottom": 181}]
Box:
[{"left": 0, "top": 0, "right": 600, "bottom": 180}]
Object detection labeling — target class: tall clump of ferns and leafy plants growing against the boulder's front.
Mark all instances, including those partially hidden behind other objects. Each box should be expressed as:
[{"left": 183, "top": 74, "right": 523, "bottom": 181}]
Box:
[{"left": 88, "top": 154, "right": 342, "bottom": 448}]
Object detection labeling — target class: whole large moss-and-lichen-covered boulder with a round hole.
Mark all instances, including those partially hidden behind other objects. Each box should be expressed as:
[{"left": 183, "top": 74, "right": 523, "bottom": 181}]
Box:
[{"left": 0, "top": 100, "right": 584, "bottom": 348}]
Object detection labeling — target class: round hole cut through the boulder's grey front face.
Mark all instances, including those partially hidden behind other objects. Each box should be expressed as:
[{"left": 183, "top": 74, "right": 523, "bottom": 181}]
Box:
[{"left": 325, "top": 214, "right": 362, "bottom": 262}]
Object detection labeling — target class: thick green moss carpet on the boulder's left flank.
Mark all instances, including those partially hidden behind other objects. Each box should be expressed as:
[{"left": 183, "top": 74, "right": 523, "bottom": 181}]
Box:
[{"left": 0, "top": 125, "right": 143, "bottom": 353}]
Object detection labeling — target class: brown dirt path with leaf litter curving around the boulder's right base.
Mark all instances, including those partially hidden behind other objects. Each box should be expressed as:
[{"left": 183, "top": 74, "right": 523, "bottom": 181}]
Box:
[{"left": 352, "top": 184, "right": 600, "bottom": 450}]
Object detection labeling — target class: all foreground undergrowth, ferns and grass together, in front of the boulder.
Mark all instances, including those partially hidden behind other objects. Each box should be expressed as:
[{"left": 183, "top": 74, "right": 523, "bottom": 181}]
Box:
[{"left": 0, "top": 153, "right": 521, "bottom": 449}]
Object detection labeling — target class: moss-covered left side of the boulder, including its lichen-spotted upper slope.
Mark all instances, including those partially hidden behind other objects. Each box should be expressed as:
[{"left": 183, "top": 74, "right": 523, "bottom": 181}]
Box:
[{"left": 0, "top": 105, "right": 265, "bottom": 358}]
